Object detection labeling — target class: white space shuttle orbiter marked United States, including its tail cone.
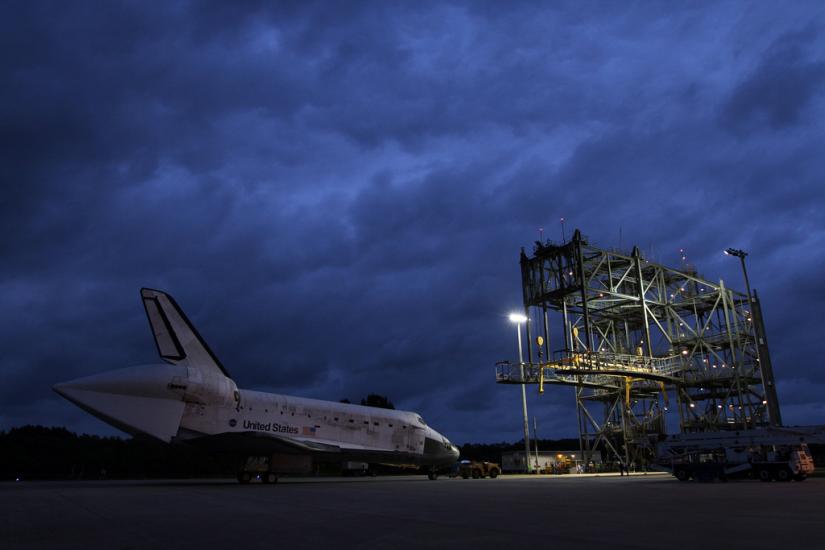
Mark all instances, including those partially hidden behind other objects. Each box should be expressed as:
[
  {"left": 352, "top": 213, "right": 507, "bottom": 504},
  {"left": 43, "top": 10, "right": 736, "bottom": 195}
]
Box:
[{"left": 54, "top": 288, "right": 458, "bottom": 482}]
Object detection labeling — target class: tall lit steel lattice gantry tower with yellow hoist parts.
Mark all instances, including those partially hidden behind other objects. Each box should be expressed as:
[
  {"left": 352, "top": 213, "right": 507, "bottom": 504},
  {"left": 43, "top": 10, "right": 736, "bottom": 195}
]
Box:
[{"left": 496, "top": 230, "right": 780, "bottom": 465}]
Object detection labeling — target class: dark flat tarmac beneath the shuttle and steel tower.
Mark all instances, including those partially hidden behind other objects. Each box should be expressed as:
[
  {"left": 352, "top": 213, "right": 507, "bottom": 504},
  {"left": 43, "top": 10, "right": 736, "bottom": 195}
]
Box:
[{"left": 0, "top": 474, "right": 825, "bottom": 550}]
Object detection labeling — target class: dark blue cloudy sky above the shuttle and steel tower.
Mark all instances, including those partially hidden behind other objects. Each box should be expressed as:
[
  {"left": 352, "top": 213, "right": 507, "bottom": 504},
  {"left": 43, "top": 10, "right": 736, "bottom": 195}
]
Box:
[{"left": 0, "top": 1, "right": 825, "bottom": 443}]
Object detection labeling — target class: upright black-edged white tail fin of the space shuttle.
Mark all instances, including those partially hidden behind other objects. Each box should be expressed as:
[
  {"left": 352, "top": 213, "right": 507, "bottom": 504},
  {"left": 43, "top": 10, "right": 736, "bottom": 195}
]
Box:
[{"left": 140, "top": 288, "right": 232, "bottom": 379}]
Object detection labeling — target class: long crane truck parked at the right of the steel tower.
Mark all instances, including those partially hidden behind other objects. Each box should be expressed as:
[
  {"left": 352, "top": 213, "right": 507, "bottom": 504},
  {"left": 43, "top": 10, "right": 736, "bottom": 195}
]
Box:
[{"left": 656, "top": 426, "right": 825, "bottom": 481}]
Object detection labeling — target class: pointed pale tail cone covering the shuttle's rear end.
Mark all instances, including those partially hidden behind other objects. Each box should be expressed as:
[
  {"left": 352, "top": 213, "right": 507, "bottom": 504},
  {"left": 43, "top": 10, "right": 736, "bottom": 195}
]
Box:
[{"left": 52, "top": 365, "right": 186, "bottom": 441}]
